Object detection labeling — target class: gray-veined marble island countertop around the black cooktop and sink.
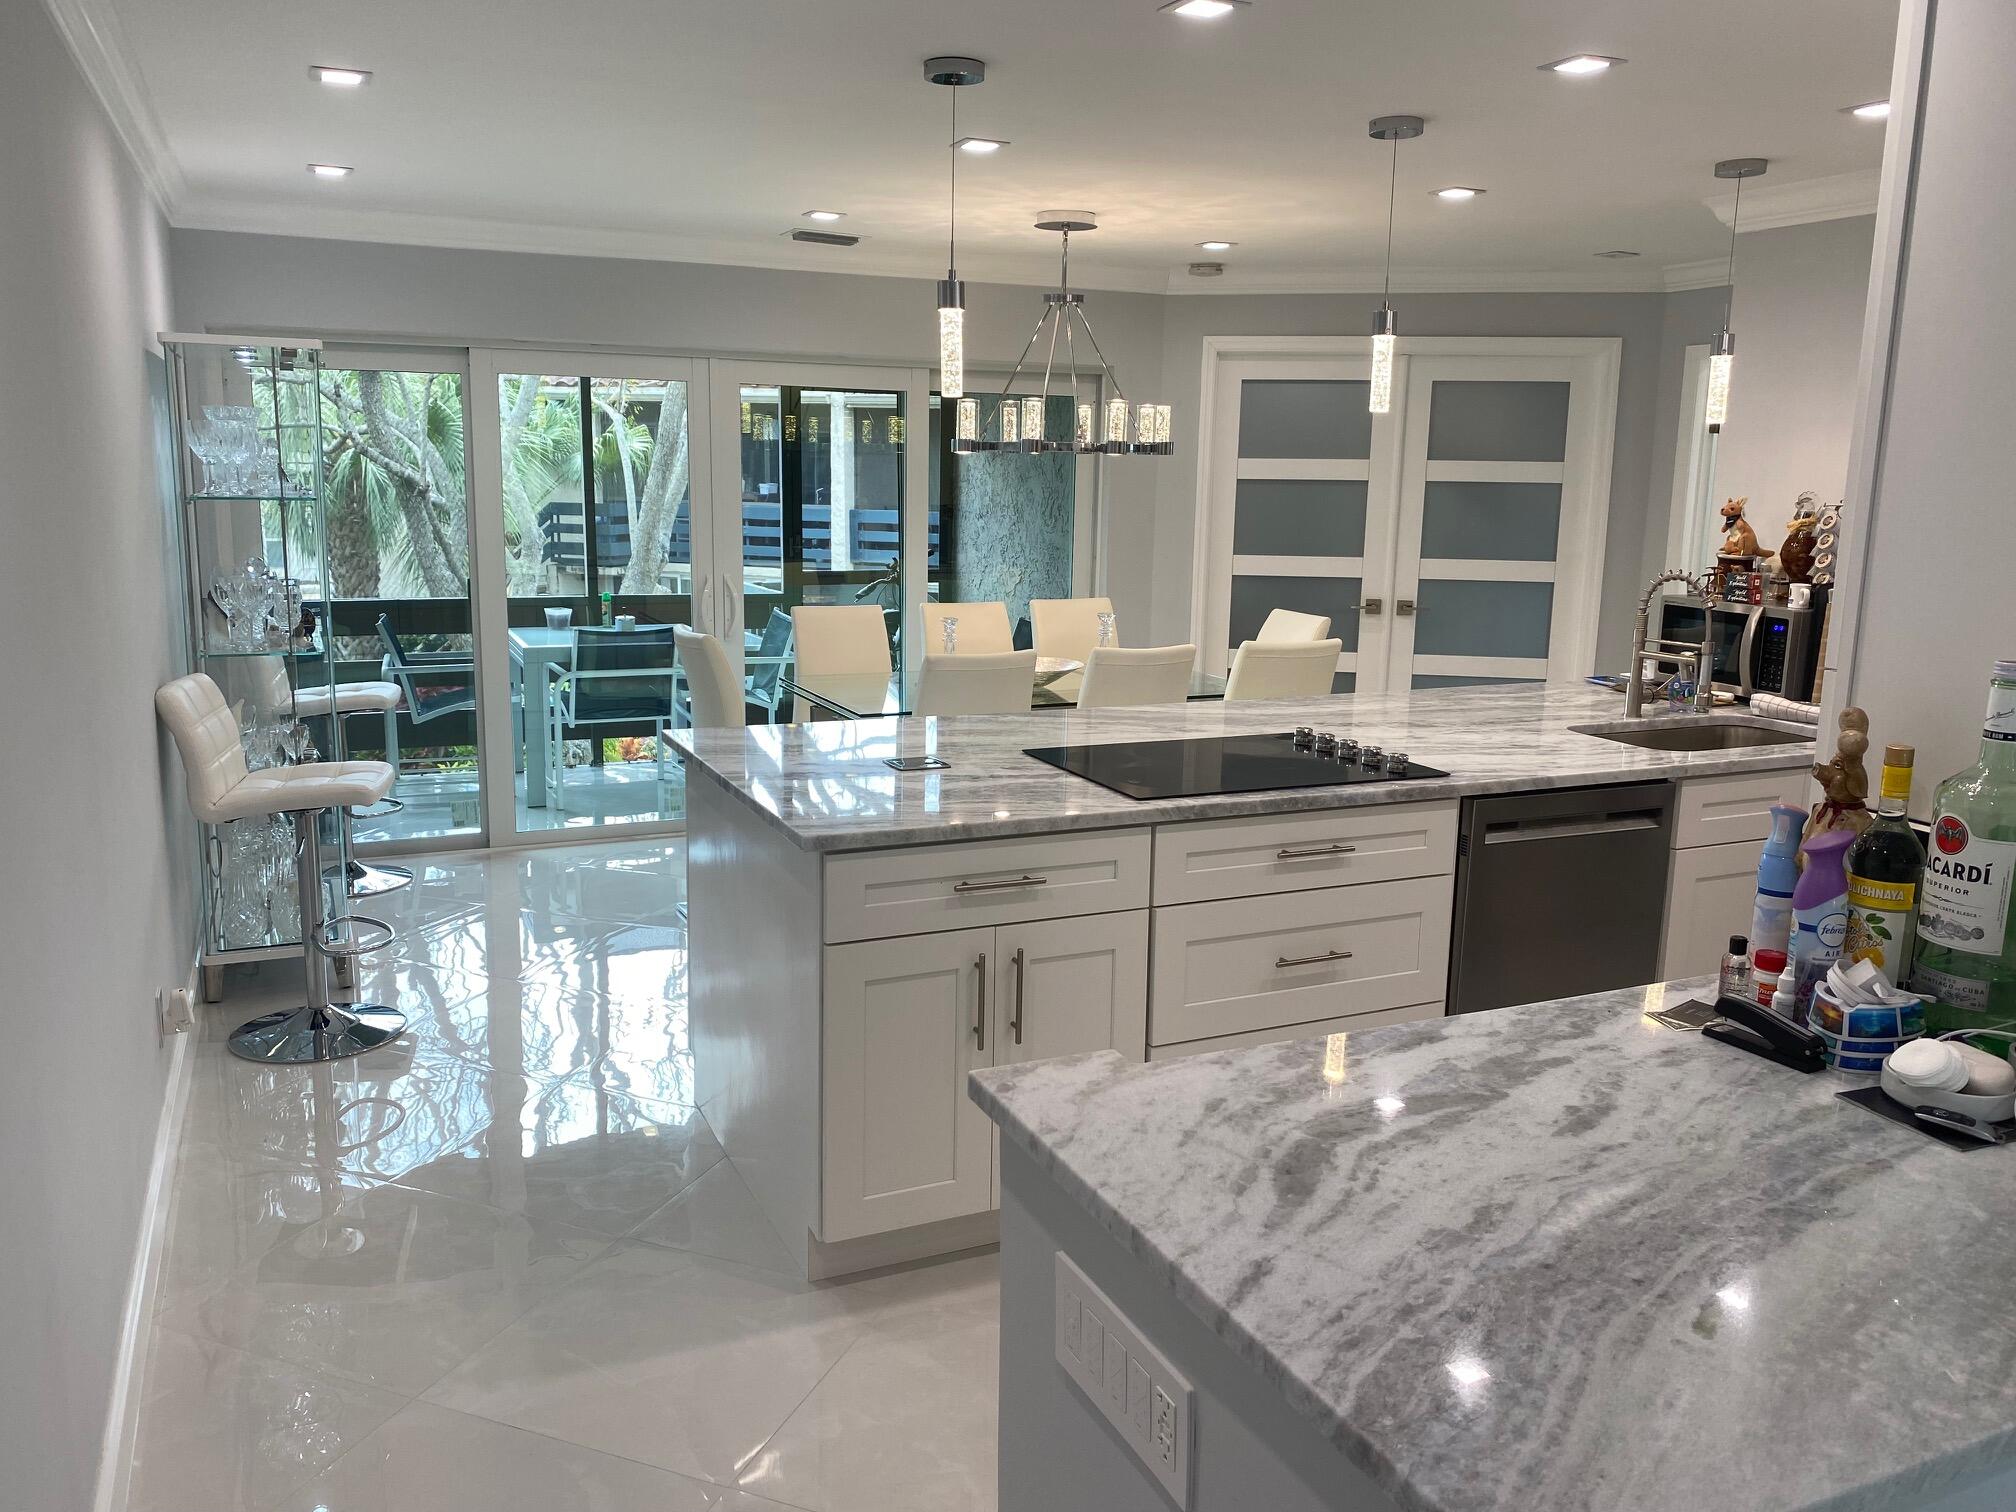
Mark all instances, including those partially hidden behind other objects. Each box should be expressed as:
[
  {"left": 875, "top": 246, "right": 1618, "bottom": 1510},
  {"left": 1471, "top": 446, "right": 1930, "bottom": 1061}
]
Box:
[{"left": 677, "top": 683, "right": 1812, "bottom": 851}]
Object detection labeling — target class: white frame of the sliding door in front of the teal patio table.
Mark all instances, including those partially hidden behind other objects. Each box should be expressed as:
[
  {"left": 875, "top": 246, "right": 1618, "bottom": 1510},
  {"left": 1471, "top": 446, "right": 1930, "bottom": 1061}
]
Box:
[{"left": 464, "top": 347, "right": 710, "bottom": 847}]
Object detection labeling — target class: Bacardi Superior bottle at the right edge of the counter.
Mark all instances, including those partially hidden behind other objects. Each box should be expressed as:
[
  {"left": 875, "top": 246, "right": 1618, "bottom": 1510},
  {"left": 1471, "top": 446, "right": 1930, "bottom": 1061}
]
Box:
[{"left": 1911, "top": 661, "right": 2016, "bottom": 1034}]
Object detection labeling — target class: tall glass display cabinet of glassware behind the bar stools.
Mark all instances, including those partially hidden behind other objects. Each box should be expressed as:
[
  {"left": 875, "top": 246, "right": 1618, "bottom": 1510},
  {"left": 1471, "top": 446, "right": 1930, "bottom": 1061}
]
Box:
[{"left": 161, "top": 333, "right": 349, "bottom": 1002}]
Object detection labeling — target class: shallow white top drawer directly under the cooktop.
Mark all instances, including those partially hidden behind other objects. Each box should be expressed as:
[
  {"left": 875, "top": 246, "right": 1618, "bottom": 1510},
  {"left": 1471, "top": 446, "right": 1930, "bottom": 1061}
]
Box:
[{"left": 1155, "top": 802, "right": 1456, "bottom": 905}]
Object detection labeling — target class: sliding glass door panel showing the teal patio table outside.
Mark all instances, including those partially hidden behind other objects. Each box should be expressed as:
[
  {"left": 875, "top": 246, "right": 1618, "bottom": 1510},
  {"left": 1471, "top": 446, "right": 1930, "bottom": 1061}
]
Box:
[{"left": 474, "top": 351, "right": 706, "bottom": 837}]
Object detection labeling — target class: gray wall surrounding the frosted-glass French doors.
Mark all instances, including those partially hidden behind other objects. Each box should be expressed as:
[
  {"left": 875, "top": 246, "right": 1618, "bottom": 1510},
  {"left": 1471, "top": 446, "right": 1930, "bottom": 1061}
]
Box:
[{"left": 1155, "top": 292, "right": 1722, "bottom": 665}]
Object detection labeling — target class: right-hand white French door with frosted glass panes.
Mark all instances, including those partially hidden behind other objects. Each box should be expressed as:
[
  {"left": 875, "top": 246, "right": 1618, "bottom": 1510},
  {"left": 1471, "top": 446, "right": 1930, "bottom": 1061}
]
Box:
[{"left": 1387, "top": 355, "right": 1613, "bottom": 689}]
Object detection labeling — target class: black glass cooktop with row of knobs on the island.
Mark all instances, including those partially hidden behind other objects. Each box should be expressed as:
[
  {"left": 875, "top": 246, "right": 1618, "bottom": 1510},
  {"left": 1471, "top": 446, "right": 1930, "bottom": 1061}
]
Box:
[{"left": 1022, "top": 732, "right": 1447, "bottom": 798}]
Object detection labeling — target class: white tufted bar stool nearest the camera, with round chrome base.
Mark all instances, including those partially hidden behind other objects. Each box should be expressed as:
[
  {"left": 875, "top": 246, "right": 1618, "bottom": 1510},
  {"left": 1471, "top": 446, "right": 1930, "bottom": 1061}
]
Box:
[{"left": 153, "top": 671, "right": 405, "bottom": 1064}]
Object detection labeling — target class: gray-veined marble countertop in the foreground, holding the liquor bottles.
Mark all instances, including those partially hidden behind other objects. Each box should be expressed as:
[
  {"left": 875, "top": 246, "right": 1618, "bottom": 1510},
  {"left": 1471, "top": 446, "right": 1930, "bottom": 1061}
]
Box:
[{"left": 972, "top": 982, "right": 2016, "bottom": 1512}]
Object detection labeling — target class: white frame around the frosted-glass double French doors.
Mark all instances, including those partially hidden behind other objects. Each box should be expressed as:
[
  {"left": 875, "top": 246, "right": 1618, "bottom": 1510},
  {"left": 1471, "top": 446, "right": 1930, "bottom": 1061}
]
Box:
[{"left": 1189, "top": 337, "right": 1623, "bottom": 691}]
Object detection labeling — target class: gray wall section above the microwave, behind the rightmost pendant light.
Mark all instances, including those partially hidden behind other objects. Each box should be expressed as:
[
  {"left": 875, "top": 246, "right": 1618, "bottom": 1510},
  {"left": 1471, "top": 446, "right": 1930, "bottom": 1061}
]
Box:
[{"left": 1716, "top": 216, "right": 1877, "bottom": 532}]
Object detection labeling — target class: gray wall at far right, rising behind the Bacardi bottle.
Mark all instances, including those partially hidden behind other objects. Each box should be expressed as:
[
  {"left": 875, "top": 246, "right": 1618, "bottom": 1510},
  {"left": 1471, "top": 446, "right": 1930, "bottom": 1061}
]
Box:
[{"left": 1845, "top": 0, "right": 2016, "bottom": 798}]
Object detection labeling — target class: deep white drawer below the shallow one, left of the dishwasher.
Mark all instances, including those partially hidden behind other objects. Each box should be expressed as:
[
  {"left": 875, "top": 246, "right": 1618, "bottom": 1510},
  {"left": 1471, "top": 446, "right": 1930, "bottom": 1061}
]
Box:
[{"left": 1147, "top": 877, "right": 1456, "bottom": 1044}]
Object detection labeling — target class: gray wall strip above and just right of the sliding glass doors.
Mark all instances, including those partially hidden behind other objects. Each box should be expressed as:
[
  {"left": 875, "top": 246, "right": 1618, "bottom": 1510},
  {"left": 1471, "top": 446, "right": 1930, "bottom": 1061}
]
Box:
[{"left": 171, "top": 230, "right": 1167, "bottom": 628}]
